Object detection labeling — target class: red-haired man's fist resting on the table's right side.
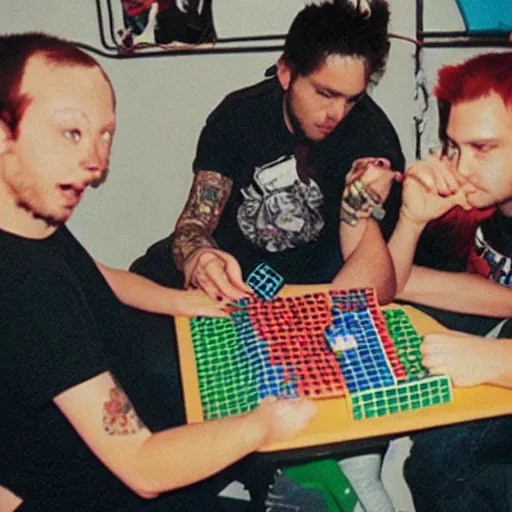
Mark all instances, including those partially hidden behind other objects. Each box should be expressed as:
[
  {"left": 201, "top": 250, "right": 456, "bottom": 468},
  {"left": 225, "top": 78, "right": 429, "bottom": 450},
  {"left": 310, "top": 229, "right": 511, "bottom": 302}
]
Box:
[{"left": 420, "top": 331, "right": 502, "bottom": 386}]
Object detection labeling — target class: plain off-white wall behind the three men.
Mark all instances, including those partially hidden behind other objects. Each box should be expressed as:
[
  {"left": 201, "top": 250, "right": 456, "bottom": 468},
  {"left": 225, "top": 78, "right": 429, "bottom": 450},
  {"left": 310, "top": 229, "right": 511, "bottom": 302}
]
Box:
[{"left": 0, "top": 0, "right": 468, "bottom": 267}]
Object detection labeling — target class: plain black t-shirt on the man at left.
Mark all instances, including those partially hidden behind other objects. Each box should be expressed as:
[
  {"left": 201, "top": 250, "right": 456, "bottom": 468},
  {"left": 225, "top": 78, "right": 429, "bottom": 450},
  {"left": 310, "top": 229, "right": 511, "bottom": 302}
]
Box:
[{"left": 0, "top": 227, "right": 214, "bottom": 512}]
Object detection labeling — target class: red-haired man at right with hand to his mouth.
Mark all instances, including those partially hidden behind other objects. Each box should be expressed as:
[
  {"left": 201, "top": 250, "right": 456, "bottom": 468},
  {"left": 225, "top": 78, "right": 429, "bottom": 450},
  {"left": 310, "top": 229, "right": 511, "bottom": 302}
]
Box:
[{"left": 389, "top": 52, "right": 512, "bottom": 512}]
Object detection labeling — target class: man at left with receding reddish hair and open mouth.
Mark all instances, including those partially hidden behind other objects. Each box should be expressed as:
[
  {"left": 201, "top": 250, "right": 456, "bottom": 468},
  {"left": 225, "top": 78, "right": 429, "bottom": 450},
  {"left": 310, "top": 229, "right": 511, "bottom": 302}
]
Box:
[{"left": 0, "top": 33, "right": 315, "bottom": 512}]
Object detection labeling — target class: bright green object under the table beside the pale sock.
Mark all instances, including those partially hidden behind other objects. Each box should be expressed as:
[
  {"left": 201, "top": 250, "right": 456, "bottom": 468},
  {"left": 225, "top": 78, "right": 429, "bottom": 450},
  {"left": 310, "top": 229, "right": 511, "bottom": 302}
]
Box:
[{"left": 283, "top": 459, "right": 357, "bottom": 512}]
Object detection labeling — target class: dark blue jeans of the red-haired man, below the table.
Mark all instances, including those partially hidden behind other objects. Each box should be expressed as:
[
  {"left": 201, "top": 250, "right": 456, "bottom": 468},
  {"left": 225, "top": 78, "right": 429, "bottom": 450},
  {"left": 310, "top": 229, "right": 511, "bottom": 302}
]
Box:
[{"left": 404, "top": 416, "right": 512, "bottom": 512}]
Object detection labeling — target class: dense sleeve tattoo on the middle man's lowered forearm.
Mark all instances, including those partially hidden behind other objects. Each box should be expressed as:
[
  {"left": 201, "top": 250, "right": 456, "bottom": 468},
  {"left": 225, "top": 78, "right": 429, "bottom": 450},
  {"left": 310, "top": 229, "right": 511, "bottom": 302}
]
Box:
[{"left": 172, "top": 171, "right": 233, "bottom": 270}]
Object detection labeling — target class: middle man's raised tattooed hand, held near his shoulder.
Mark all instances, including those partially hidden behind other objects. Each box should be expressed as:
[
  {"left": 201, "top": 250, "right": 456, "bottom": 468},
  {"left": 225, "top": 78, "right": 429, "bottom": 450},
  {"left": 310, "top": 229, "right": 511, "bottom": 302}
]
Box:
[{"left": 341, "top": 157, "right": 403, "bottom": 225}]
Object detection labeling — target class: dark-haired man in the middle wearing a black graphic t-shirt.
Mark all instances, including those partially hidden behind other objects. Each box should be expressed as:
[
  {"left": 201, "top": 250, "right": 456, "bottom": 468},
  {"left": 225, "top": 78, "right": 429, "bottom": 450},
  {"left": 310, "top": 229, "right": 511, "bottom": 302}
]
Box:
[{"left": 131, "top": 0, "right": 404, "bottom": 512}]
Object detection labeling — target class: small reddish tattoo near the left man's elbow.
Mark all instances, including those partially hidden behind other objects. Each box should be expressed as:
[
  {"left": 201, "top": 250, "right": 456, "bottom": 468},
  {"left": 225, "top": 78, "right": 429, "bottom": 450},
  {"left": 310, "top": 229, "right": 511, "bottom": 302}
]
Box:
[{"left": 103, "top": 382, "right": 145, "bottom": 436}]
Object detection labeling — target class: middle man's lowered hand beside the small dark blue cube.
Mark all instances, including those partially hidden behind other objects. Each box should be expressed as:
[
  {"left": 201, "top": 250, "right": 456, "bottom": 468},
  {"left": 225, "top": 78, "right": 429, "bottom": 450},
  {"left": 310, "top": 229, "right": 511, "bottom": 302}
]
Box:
[{"left": 184, "top": 248, "right": 253, "bottom": 302}]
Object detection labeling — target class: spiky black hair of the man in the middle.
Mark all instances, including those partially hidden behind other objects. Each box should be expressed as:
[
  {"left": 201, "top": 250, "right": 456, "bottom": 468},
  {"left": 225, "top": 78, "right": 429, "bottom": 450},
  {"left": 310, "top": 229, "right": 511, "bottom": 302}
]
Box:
[{"left": 282, "top": 0, "right": 390, "bottom": 77}]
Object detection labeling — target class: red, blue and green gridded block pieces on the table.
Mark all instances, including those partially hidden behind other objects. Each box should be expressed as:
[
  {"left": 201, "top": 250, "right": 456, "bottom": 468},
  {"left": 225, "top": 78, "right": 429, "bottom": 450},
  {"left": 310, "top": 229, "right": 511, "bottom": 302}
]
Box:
[{"left": 190, "top": 266, "right": 452, "bottom": 420}]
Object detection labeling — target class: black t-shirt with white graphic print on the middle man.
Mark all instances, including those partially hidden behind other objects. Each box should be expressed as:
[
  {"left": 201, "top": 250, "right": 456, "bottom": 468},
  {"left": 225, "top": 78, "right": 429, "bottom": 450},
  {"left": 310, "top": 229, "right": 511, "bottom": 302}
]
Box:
[{"left": 193, "top": 78, "right": 404, "bottom": 283}]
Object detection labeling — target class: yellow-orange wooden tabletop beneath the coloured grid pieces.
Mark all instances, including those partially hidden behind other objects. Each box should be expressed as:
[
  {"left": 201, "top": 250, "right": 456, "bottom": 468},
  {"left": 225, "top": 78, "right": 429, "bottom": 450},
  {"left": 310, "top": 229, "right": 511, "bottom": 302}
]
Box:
[{"left": 176, "top": 285, "right": 512, "bottom": 459}]
